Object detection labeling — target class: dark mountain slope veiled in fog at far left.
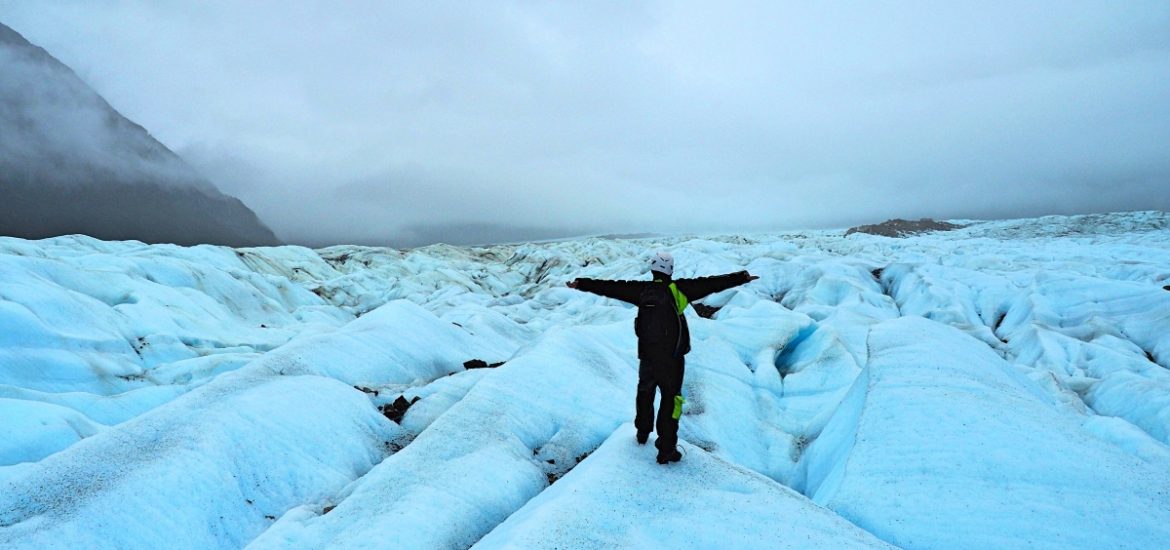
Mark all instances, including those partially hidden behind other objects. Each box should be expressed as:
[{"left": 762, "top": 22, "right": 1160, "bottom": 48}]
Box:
[{"left": 0, "top": 23, "right": 278, "bottom": 246}]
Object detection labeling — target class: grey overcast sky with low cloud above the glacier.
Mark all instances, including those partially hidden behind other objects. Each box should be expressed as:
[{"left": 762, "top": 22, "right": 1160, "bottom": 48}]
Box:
[{"left": 0, "top": 0, "right": 1170, "bottom": 245}]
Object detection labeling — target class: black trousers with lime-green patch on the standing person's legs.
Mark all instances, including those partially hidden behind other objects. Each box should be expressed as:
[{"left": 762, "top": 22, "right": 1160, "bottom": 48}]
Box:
[{"left": 634, "top": 356, "right": 686, "bottom": 453}]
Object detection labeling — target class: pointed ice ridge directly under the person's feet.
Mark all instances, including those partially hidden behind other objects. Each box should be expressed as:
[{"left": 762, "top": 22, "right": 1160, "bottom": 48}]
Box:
[{"left": 473, "top": 425, "right": 889, "bottom": 549}]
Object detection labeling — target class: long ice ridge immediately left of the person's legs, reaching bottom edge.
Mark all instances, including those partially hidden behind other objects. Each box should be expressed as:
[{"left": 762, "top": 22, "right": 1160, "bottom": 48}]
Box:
[{"left": 250, "top": 326, "right": 636, "bottom": 549}]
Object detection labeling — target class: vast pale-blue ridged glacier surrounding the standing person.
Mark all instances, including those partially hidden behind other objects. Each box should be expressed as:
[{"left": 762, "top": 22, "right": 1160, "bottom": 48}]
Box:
[{"left": 0, "top": 212, "right": 1170, "bottom": 549}]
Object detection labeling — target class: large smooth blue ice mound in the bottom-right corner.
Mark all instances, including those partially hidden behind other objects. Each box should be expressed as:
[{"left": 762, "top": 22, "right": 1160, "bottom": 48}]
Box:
[{"left": 803, "top": 317, "right": 1170, "bottom": 548}]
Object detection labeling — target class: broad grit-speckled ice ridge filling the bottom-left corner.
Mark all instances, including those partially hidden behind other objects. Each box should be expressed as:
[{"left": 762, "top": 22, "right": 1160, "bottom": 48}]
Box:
[{"left": 0, "top": 374, "right": 397, "bottom": 548}]
